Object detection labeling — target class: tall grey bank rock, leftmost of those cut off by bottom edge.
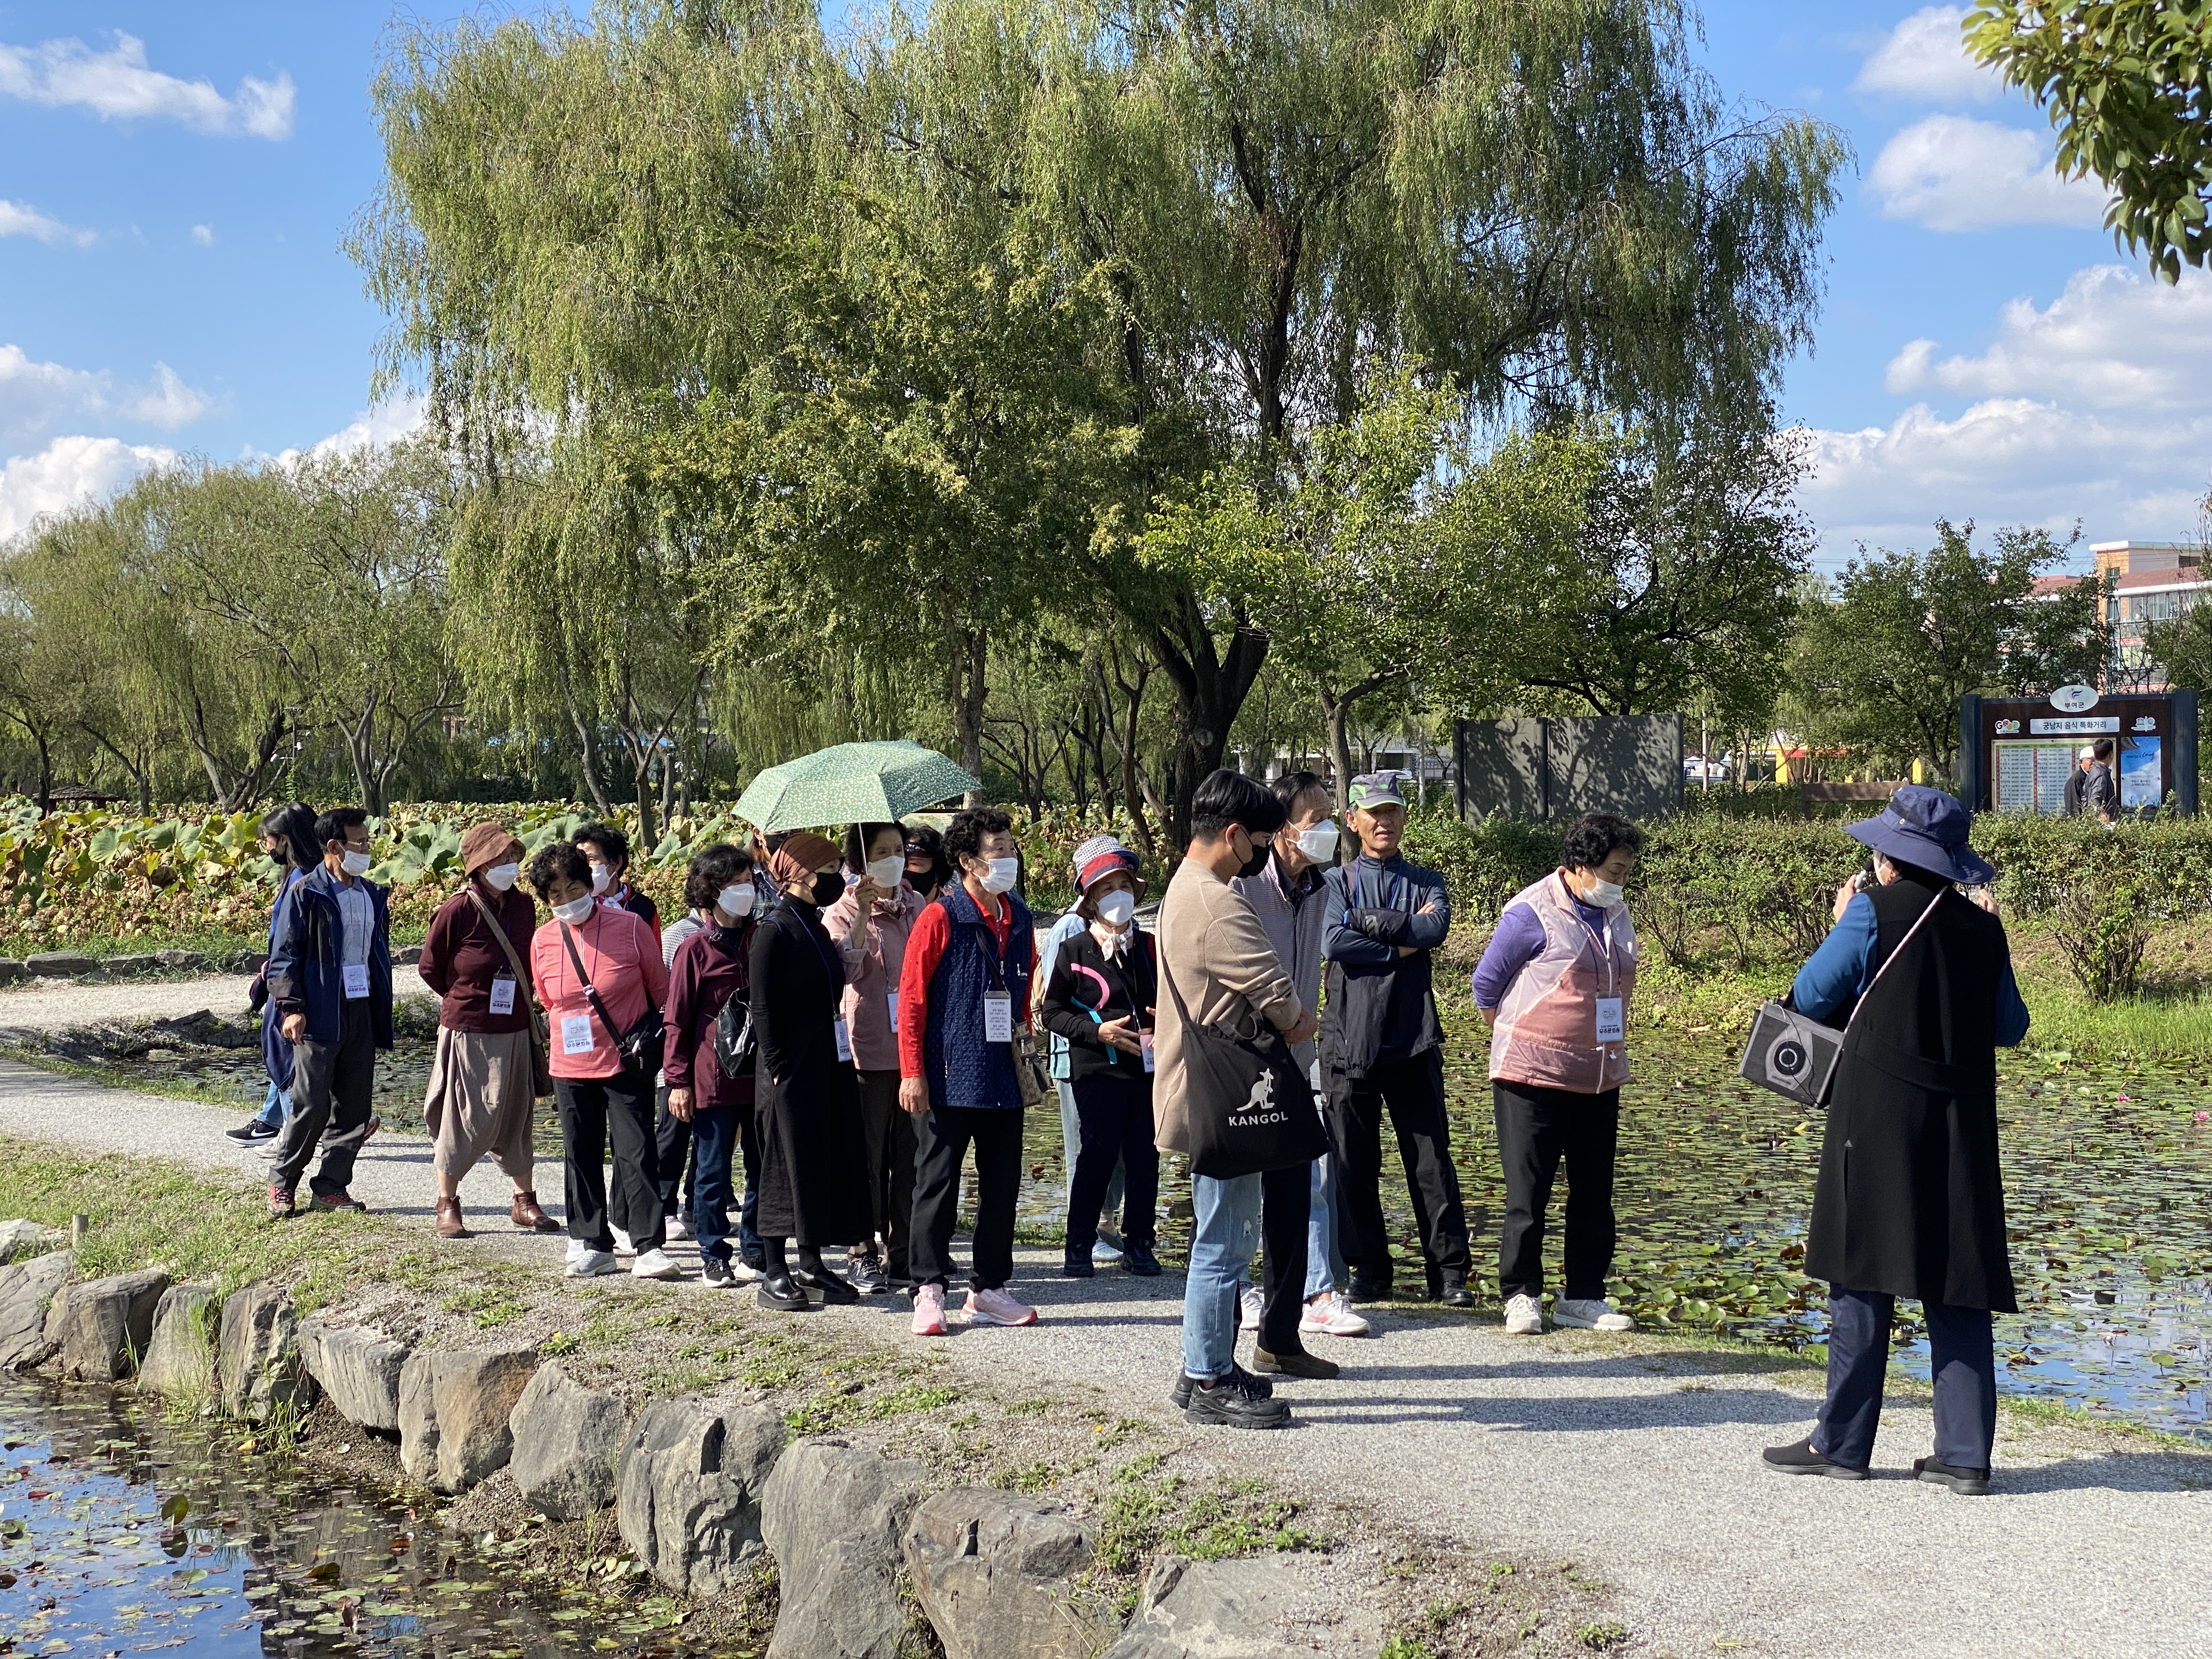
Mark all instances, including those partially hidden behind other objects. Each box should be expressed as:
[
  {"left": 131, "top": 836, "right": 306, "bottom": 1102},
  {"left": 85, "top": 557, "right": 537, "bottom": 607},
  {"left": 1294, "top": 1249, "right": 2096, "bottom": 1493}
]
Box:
[{"left": 761, "top": 1440, "right": 924, "bottom": 1659}]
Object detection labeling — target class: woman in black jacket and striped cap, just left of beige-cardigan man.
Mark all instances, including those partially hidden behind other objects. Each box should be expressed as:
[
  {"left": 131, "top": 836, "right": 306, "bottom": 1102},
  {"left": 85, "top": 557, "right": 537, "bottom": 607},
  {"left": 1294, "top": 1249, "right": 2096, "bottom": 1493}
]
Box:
[{"left": 1040, "top": 847, "right": 1159, "bottom": 1278}]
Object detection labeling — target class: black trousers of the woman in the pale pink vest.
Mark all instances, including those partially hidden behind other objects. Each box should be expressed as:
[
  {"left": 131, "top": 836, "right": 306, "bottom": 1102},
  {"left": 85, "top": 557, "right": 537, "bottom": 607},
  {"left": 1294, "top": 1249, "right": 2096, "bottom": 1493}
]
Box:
[{"left": 1491, "top": 1082, "right": 1621, "bottom": 1301}]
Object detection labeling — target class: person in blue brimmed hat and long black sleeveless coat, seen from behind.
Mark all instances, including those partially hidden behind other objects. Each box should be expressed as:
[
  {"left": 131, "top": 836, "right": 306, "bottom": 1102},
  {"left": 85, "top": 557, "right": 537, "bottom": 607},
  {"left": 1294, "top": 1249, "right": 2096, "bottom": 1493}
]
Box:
[{"left": 1765, "top": 783, "right": 2028, "bottom": 1498}]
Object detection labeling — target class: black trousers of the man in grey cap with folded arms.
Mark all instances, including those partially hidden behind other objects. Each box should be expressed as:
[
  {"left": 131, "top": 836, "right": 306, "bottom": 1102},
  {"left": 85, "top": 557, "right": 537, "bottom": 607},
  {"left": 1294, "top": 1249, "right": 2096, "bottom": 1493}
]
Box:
[{"left": 1327, "top": 1048, "right": 1469, "bottom": 1294}]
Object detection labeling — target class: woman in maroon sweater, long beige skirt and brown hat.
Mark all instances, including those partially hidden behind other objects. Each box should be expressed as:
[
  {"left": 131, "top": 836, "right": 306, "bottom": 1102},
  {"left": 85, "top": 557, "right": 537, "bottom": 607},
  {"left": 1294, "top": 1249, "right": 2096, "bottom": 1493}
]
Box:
[{"left": 416, "top": 823, "right": 560, "bottom": 1239}]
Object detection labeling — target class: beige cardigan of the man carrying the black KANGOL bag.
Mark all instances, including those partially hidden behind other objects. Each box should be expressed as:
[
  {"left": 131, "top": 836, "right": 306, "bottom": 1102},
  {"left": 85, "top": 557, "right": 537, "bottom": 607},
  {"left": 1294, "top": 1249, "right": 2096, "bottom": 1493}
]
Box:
[{"left": 1153, "top": 858, "right": 1305, "bottom": 1153}]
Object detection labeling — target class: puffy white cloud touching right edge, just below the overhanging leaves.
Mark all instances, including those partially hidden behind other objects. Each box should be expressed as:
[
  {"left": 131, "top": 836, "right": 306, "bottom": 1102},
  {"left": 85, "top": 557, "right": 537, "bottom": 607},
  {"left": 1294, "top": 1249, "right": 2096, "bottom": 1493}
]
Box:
[{"left": 1882, "top": 266, "right": 2212, "bottom": 414}]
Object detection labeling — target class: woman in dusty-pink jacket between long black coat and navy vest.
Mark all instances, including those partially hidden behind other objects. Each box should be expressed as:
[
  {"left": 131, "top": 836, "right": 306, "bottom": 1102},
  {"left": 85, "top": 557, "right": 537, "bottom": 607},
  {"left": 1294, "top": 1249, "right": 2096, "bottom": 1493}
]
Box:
[{"left": 823, "top": 823, "right": 929, "bottom": 1296}]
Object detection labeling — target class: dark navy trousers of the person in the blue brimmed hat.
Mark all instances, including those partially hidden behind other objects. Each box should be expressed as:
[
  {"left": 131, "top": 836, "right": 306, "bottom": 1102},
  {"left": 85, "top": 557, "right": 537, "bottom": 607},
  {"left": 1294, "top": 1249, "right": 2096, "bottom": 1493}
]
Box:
[{"left": 1812, "top": 1285, "right": 1997, "bottom": 1469}]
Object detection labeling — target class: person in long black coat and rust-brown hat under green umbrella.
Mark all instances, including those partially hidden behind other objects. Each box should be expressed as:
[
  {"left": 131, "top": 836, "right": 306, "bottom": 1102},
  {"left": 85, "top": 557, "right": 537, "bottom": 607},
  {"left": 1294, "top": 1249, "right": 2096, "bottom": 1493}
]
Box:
[{"left": 750, "top": 832, "right": 872, "bottom": 1310}]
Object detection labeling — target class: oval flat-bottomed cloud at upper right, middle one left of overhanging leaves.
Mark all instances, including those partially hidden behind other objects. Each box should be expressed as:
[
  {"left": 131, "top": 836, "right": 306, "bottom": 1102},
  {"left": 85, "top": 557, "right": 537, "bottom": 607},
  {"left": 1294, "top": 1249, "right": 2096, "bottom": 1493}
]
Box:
[{"left": 1867, "top": 115, "right": 2106, "bottom": 230}]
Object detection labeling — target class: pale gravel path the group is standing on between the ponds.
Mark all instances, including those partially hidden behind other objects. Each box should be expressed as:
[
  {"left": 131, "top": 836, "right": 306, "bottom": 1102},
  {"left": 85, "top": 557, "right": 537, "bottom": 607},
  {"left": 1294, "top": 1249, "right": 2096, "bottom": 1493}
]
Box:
[{"left": 0, "top": 980, "right": 2212, "bottom": 1659}]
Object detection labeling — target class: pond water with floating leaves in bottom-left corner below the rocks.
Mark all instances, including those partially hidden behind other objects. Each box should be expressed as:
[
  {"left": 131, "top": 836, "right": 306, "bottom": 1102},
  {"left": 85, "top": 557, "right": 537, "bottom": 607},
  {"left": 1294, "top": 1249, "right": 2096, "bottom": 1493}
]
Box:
[{"left": 0, "top": 1376, "right": 679, "bottom": 1659}]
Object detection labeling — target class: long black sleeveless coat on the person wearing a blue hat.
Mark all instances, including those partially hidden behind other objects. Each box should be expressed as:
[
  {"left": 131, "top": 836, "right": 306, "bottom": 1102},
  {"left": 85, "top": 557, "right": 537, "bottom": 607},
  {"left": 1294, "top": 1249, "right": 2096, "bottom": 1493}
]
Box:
[{"left": 1805, "top": 876, "right": 2017, "bottom": 1314}]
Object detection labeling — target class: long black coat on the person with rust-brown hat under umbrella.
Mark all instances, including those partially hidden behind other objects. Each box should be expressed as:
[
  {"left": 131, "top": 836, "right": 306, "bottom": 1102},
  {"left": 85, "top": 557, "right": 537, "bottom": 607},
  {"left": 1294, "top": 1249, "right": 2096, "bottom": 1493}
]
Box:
[{"left": 750, "top": 898, "right": 874, "bottom": 1248}]
